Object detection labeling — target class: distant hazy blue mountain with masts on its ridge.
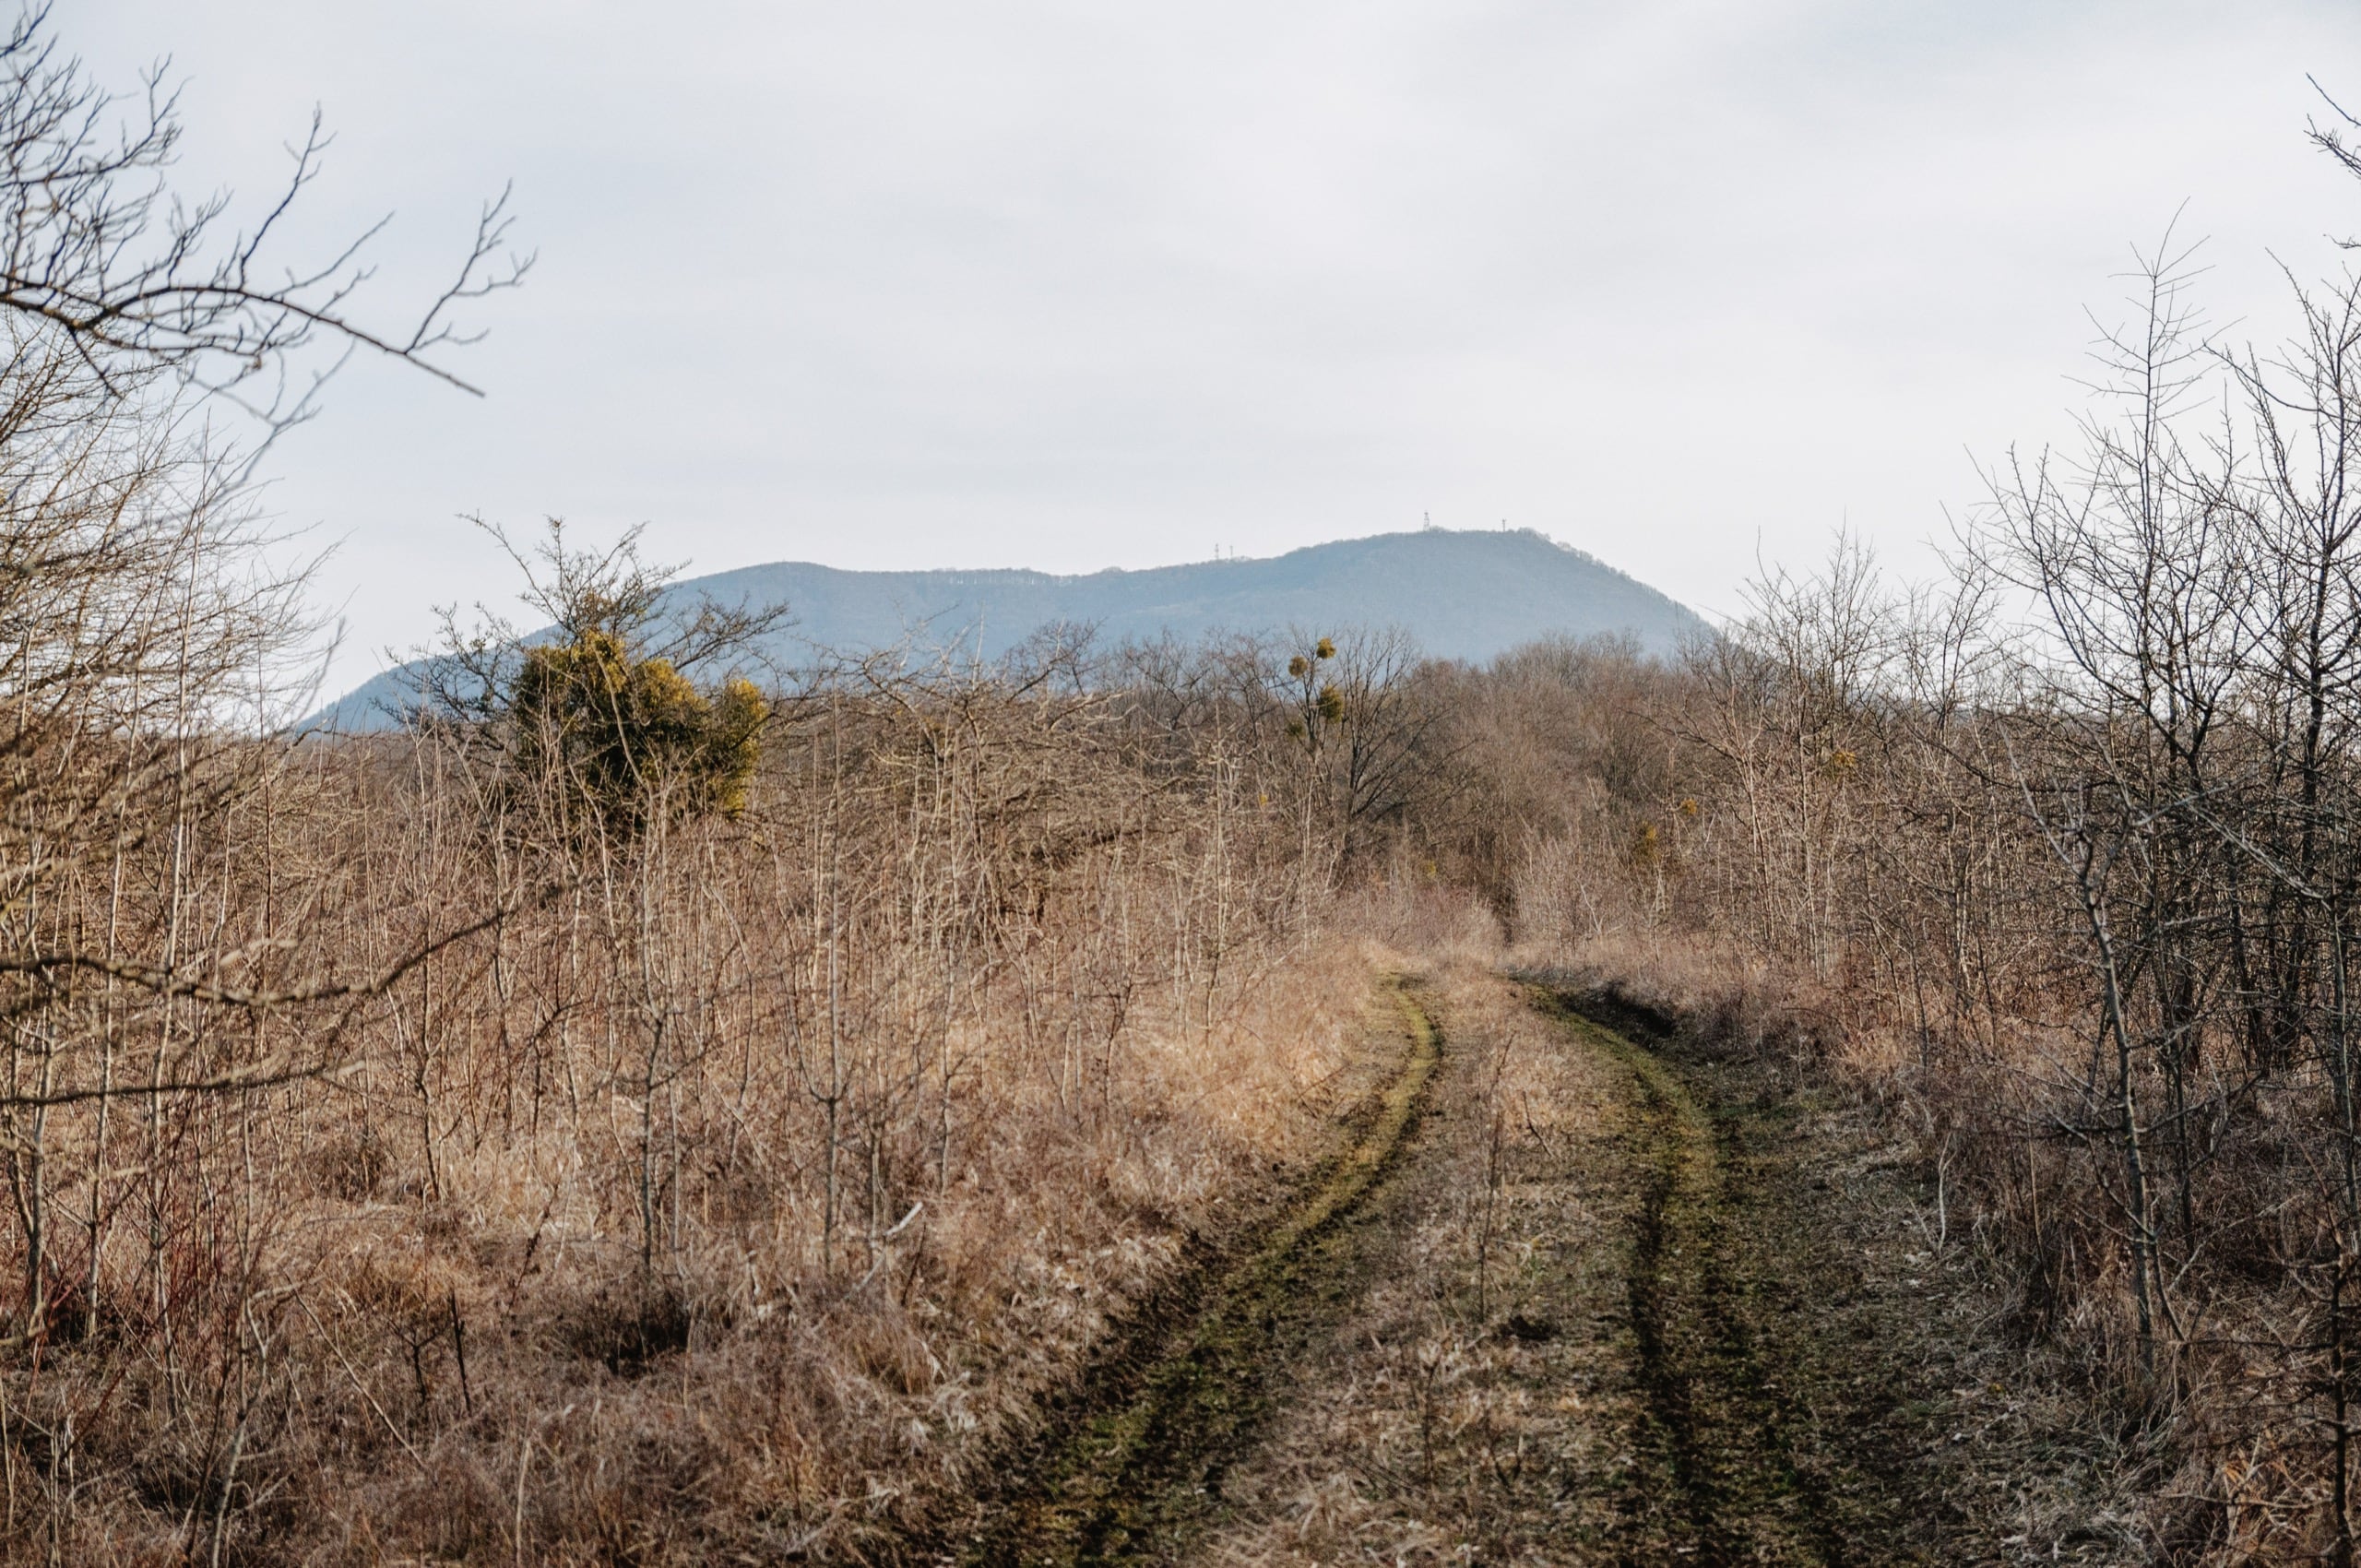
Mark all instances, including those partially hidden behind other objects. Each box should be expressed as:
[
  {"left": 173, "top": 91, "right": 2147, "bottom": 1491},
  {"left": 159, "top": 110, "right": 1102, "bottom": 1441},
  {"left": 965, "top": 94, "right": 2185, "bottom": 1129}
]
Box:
[{"left": 309, "top": 529, "right": 1707, "bottom": 730}]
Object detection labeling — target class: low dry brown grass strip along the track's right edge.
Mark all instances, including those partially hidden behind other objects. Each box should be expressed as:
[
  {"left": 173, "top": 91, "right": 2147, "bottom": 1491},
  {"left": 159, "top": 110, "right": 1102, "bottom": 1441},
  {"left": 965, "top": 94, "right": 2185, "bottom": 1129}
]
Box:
[{"left": 1527, "top": 932, "right": 2200, "bottom": 1563}]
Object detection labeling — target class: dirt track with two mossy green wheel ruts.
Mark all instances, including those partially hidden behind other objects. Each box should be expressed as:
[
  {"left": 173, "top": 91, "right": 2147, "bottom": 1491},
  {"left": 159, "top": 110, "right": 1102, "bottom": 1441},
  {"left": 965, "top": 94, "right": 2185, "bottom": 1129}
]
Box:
[{"left": 940, "top": 975, "right": 2137, "bottom": 1565}]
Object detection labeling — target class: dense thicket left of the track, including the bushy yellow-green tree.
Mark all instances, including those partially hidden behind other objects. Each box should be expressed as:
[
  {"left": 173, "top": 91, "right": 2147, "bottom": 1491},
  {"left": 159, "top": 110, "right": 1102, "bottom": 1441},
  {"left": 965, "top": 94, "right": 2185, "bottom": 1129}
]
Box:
[{"left": 0, "top": 503, "right": 1482, "bottom": 1561}]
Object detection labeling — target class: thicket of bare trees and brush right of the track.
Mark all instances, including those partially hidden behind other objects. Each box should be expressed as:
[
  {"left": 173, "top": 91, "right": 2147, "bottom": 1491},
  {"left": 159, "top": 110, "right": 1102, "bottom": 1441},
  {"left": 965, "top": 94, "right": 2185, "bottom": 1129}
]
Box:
[{"left": 1438, "top": 242, "right": 2361, "bottom": 1561}]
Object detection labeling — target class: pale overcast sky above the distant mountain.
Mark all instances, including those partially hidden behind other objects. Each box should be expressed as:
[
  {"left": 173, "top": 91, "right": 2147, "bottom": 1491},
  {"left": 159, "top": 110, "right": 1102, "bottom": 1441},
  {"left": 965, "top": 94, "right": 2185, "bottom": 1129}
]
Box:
[{"left": 54, "top": 0, "right": 2361, "bottom": 684}]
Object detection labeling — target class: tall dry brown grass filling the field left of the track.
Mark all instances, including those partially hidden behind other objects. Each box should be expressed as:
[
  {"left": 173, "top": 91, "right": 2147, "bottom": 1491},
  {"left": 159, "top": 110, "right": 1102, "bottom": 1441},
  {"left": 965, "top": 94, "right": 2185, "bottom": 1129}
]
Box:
[{"left": 0, "top": 704, "right": 1386, "bottom": 1563}]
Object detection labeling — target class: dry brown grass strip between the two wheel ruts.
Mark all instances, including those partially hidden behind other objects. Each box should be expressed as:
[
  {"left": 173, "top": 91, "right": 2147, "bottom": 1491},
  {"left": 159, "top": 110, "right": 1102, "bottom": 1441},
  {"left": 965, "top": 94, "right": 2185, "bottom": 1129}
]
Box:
[{"left": 1206, "top": 952, "right": 1627, "bottom": 1565}]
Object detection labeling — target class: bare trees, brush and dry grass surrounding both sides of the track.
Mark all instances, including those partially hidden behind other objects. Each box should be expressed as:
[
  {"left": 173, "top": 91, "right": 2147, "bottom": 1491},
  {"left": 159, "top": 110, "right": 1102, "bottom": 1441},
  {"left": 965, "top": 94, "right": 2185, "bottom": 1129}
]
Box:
[{"left": 22, "top": 12, "right": 2361, "bottom": 1563}]
